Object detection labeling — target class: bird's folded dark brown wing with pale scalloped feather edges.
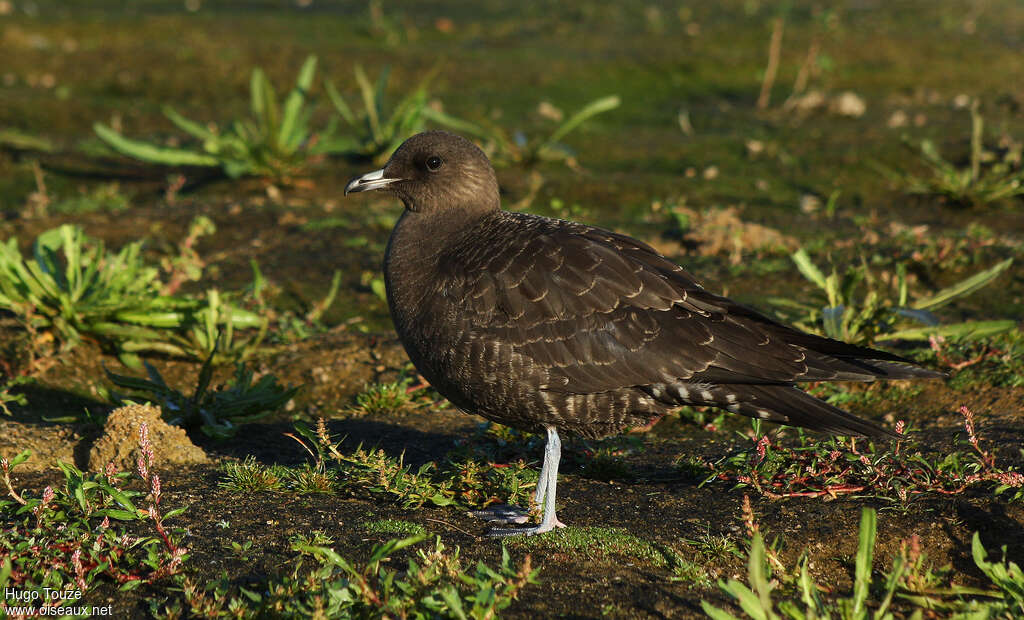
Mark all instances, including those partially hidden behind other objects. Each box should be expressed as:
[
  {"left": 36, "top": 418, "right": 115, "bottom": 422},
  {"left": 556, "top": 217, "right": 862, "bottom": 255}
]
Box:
[{"left": 440, "top": 220, "right": 921, "bottom": 392}]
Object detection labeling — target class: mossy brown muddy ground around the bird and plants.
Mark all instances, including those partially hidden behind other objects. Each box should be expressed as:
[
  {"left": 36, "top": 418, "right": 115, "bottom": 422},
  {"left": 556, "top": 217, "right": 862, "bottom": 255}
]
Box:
[{"left": 0, "top": 0, "right": 1024, "bottom": 618}]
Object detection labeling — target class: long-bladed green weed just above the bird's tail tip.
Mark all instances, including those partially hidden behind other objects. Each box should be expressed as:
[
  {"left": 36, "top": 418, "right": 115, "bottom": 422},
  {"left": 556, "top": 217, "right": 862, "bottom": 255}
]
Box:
[{"left": 772, "top": 249, "right": 1017, "bottom": 343}]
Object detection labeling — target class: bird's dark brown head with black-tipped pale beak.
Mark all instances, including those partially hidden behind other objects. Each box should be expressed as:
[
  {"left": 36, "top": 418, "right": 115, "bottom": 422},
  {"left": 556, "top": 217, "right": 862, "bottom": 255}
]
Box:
[{"left": 345, "top": 131, "right": 501, "bottom": 214}]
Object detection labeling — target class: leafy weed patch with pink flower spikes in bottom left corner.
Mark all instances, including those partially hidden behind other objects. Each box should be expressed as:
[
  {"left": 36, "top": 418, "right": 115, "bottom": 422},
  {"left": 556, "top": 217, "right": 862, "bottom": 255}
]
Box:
[{"left": 0, "top": 424, "right": 188, "bottom": 615}]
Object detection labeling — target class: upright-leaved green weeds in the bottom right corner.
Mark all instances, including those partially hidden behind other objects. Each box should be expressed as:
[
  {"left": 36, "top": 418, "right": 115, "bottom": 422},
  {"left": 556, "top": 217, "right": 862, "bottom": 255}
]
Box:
[{"left": 701, "top": 508, "right": 1024, "bottom": 620}]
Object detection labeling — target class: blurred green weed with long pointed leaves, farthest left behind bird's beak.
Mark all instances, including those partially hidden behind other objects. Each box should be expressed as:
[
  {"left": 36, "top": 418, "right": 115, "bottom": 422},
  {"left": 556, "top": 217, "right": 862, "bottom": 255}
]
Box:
[{"left": 93, "top": 55, "right": 329, "bottom": 181}]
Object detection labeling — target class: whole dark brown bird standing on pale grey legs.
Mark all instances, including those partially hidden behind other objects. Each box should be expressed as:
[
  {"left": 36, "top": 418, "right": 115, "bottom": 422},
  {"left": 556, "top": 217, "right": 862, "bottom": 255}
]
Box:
[{"left": 345, "top": 131, "right": 944, "bottom": 536}]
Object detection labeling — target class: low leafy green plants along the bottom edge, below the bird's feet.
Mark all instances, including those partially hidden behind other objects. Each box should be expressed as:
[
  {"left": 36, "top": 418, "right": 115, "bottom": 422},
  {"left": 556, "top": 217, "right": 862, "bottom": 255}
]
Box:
[{"left": 157, "top": 534, "right": 539, "bottom": 620}]
